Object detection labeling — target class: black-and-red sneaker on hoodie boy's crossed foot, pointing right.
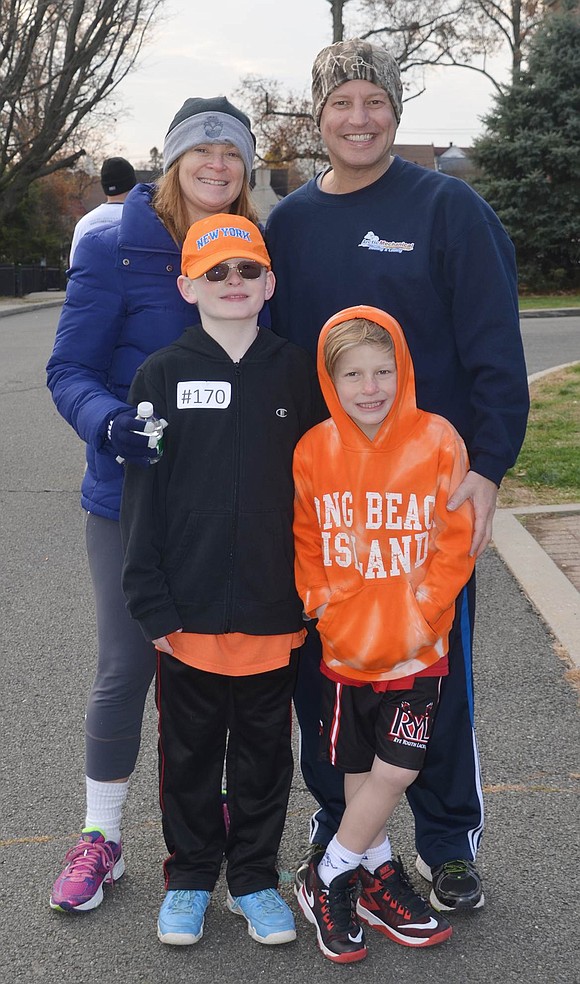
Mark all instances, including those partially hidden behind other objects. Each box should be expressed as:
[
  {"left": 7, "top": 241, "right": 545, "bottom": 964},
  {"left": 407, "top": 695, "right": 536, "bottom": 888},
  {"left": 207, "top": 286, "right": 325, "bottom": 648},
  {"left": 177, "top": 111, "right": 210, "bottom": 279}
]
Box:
[{"left": 357, "top": 859, "right": 452, "bottom": 947}]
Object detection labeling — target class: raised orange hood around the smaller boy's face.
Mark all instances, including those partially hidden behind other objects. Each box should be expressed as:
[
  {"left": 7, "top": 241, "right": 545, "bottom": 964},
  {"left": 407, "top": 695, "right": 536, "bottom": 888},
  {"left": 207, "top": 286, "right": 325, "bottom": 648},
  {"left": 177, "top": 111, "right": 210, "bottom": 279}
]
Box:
[{"left": 317, "top": 304, "right": 420, "bottom": 452}]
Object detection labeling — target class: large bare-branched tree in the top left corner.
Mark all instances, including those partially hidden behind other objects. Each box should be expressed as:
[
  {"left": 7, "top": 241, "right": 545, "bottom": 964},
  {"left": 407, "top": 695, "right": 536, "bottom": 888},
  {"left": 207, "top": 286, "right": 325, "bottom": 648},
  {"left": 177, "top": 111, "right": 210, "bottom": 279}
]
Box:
[{"left": 0, "top": 0, "right": 163, "bottom": 221}]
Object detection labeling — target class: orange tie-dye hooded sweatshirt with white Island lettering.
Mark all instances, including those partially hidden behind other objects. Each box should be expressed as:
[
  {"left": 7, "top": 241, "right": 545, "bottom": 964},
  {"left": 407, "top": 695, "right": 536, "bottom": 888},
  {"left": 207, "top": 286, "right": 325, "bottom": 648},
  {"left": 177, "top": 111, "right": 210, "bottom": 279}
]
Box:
[{"left": 294, "top": 305, "right": 474, "bottom": 683}]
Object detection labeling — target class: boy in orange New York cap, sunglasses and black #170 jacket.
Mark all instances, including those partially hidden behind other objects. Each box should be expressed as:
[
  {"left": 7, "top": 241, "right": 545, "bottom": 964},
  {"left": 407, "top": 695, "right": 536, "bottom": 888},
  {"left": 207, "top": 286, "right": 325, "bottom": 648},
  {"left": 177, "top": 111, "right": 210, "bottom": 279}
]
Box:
[{"left": 121, "top": 214, "right": 325, "bottom": 945}]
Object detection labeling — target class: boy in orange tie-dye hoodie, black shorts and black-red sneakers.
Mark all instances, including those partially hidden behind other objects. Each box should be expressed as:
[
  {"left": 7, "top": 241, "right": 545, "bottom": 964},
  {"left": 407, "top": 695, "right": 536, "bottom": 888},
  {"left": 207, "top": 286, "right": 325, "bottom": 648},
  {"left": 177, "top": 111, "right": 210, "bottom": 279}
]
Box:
[{"left": 294, "top": 305, "right": 474, "bottom": 963}]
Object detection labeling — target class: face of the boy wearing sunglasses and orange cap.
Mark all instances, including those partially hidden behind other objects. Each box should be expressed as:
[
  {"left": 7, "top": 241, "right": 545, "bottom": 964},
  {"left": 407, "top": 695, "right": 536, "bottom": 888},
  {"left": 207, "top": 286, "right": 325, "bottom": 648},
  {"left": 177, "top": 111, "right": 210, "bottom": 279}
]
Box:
[{"left": 177, "top": 256, "right": 276, "bottom": 324}]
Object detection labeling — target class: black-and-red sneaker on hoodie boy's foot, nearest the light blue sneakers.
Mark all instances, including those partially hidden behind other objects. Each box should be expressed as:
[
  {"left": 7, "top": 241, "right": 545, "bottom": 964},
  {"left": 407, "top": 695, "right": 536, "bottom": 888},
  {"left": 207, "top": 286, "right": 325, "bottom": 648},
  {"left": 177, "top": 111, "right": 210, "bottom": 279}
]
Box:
[{"left": 297, "top": 861, "right": 367, "bottom": 963}]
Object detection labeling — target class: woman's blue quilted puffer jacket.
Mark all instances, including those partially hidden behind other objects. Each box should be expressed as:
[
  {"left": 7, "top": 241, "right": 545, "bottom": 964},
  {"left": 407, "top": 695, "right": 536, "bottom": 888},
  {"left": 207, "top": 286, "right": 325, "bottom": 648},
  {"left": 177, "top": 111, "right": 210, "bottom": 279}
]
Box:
[{"left": 47, "top": 184, "right": 193, "bottom": 519}]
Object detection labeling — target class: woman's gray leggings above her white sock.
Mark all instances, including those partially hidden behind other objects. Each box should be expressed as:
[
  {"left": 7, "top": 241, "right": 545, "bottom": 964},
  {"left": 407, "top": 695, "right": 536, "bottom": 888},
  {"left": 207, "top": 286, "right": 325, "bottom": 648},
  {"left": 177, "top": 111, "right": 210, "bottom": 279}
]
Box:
[{"left": 86, "top": 513, "right": 156, "bottom": 782}]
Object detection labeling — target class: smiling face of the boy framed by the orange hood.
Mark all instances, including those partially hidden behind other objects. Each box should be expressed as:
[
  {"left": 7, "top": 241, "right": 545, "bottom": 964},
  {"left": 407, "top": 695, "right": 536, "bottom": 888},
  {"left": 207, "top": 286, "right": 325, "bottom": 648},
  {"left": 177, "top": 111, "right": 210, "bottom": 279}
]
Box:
[{"left": 333, "top": 342, "right": 397, "bottom": 441}]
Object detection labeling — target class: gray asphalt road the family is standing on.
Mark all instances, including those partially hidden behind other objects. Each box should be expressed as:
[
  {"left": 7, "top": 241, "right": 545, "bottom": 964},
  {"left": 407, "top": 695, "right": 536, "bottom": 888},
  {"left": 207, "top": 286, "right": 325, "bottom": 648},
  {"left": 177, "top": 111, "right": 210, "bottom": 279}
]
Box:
[{"left": 0, "top": 310, "right": 580, "bottom": 984}]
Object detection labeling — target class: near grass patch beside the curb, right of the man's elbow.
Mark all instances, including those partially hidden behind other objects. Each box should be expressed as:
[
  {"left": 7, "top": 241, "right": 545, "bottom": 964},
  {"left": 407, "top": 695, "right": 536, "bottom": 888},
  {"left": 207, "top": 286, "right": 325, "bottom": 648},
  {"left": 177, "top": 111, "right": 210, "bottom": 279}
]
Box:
[{"left": 498, "top": 365, "right": 580, "bottom": 508}]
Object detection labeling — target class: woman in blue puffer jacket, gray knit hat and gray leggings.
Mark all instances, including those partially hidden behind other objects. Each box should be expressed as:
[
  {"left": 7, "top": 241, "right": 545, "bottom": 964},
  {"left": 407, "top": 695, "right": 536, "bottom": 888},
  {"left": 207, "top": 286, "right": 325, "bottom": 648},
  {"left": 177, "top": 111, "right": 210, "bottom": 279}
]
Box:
[{"left": 47, "top": 96, "right": 256, "bottom": 912}]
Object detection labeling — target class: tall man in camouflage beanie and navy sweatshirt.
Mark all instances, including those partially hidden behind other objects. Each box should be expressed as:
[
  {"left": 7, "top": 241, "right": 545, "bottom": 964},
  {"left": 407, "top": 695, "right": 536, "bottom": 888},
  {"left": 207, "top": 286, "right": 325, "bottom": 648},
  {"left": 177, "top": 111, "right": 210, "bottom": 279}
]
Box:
[{"left": 266, "top": 38, "right": 529, "bottom": 910}]
